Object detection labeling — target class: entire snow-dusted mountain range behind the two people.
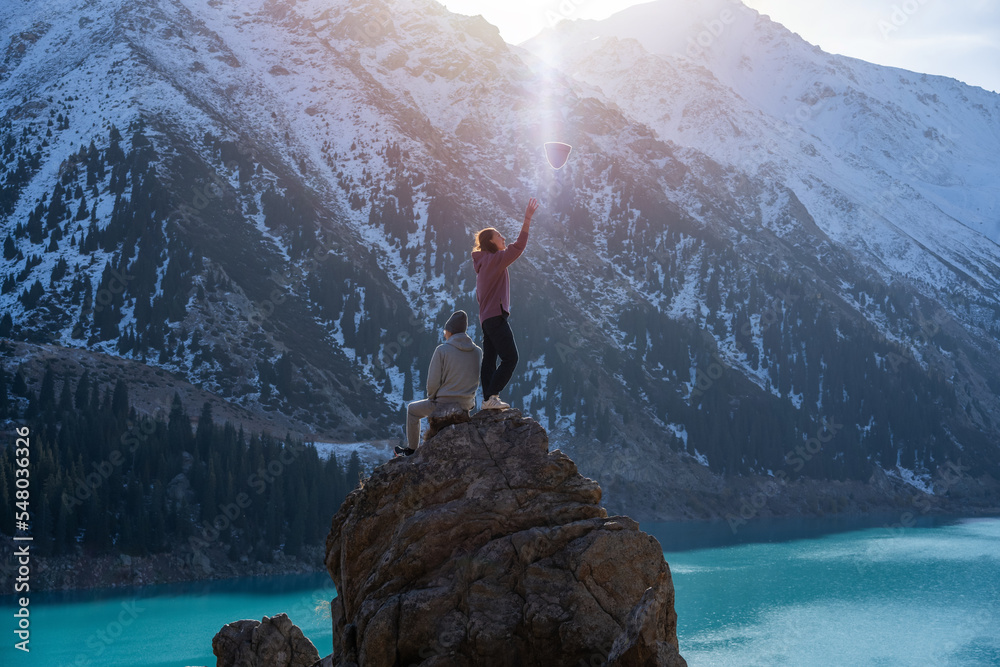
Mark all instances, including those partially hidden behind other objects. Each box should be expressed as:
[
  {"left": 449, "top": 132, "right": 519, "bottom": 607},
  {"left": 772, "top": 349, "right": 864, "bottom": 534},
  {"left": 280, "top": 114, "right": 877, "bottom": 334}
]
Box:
[{"left": 0, "top": 0, "right": 1000, "bottom": 517}]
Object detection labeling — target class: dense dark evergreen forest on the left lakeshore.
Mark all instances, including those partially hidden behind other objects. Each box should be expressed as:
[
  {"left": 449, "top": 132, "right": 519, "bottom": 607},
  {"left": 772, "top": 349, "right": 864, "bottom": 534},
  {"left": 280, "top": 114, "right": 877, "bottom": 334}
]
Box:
[{"left": 0, "top": 368, "right": 361, "bottom": 560}]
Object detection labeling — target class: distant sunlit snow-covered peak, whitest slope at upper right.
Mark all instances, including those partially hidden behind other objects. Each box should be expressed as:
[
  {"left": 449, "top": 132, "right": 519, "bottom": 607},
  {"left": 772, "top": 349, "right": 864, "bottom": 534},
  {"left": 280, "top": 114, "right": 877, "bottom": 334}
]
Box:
[{"left": 524, "top": 0, "right": 1000, "bottom": 306}]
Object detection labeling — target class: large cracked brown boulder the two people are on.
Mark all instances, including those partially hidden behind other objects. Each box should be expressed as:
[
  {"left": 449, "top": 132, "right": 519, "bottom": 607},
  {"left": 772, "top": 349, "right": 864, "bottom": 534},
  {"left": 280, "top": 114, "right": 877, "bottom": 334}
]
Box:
[{"left": 326, "top": 410, "right": 685, "bottom": 667}]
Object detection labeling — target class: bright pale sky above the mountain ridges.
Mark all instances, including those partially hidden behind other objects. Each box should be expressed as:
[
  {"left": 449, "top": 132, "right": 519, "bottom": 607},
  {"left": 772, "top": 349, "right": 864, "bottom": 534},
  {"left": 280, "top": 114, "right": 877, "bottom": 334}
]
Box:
[{"left": 439, "top": 0, "right": 1000, "bottom": 92}]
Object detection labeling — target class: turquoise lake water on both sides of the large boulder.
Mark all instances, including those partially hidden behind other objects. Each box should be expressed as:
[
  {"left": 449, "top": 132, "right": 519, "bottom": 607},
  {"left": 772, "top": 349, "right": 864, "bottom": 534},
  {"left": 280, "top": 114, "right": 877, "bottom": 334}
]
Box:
[{"left": 0, "top": 517, "right": 1000, "bottom": 667}]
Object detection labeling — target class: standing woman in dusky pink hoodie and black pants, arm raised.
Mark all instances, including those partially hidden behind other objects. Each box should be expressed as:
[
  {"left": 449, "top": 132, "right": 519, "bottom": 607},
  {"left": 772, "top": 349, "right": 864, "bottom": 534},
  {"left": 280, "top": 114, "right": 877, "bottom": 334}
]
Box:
[{"left": 472, "top": 197, "right": 538, "bottom": 410}]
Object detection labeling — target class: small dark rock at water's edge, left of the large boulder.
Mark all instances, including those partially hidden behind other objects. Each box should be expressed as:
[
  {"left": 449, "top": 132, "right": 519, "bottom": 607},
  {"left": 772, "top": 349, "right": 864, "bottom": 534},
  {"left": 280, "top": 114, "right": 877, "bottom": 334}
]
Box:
[{"left": 212, "top": 614, "right": 320, "bottom": 667}]
